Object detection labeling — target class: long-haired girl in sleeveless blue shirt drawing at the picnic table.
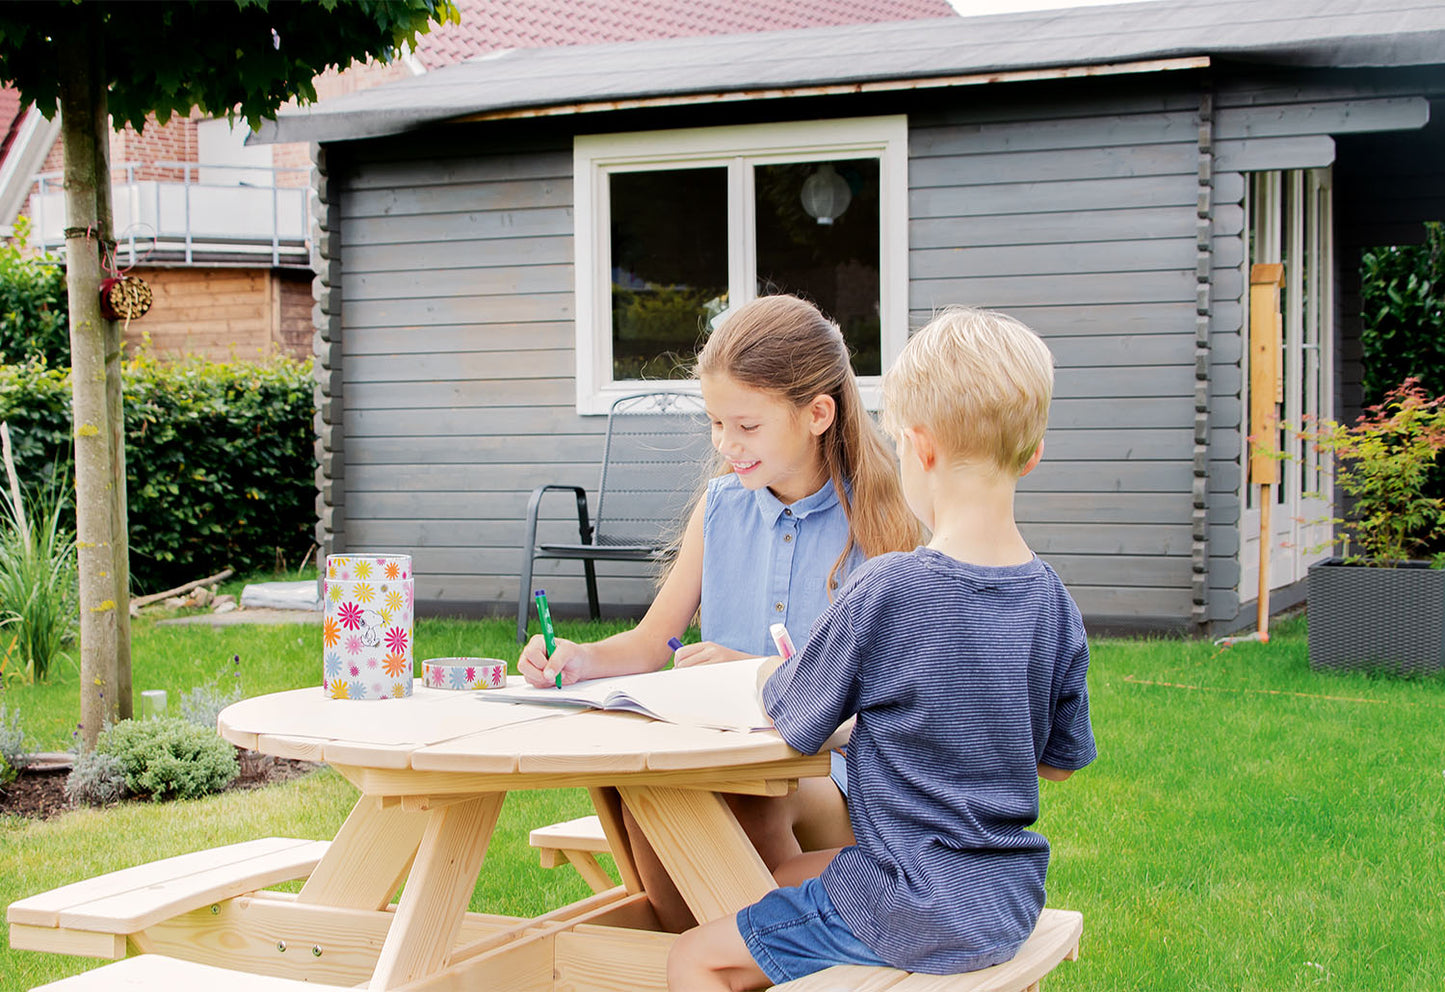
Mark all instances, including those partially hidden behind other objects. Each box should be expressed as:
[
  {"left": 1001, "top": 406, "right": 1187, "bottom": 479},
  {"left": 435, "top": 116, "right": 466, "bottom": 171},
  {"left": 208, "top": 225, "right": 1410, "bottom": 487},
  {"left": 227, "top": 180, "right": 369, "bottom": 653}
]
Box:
[{"left": 517, "top": 296, "right": 919, "bottom": 928}]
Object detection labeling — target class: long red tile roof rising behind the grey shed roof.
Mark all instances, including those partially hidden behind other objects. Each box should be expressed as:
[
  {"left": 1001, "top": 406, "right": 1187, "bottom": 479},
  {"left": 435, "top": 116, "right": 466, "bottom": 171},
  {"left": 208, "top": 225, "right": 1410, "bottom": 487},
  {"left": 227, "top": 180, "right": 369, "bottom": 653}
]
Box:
[{"left": 416, "top": 0, "right": 955, "bottom": 71}]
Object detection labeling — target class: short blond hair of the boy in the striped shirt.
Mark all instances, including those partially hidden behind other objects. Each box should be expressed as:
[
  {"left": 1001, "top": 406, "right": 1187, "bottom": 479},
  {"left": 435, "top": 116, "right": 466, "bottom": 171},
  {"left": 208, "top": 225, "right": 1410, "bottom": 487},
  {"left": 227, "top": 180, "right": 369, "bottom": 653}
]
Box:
[{"left": 883, "top": 306, "right": 1053, "bottom": 472}]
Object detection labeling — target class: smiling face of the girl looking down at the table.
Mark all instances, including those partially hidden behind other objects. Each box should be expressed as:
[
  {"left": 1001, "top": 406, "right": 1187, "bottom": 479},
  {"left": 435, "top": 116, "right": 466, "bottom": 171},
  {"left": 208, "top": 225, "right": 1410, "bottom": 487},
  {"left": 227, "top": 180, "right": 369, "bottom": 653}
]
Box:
[{"left": 699, "top": 374, "right": 837, "bottom": 502}]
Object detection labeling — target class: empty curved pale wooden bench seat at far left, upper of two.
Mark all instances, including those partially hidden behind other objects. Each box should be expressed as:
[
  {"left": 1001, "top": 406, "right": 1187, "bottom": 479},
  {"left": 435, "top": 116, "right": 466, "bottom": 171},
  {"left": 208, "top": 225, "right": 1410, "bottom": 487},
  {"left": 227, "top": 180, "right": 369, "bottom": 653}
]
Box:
[{"left": 6, "top": 837, "right": 331, "bottom": 959}]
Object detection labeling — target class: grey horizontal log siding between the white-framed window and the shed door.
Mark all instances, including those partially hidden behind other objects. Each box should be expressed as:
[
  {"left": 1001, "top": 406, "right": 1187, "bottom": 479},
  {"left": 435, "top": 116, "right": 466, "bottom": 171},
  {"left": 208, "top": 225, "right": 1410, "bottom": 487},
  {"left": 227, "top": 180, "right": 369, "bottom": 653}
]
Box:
[{"left": 909, "top": 84, "right": 1211, "bottom": 627}]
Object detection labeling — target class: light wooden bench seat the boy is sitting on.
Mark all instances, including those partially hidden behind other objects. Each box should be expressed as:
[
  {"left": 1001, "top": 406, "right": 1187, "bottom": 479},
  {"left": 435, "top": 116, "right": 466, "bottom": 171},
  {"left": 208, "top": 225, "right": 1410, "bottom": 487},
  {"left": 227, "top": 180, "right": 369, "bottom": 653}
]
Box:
[{"left": 773, "top": 910, "right": 1084, "bottom": 992}]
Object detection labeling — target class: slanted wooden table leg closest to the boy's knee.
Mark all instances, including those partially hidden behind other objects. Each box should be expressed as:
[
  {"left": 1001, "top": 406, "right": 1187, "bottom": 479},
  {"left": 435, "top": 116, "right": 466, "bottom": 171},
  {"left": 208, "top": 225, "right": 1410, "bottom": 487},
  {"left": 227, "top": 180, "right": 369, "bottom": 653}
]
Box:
[{"left": 618, "top": 786, "right": 776, "bottom": 923}]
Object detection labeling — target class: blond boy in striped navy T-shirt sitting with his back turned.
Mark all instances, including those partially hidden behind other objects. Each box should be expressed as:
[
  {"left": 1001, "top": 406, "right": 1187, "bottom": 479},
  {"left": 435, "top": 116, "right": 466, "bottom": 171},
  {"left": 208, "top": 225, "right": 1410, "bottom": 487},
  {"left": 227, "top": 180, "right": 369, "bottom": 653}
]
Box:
[{"left": 668, "top": 309, "right": 1095, "bottom": 992}]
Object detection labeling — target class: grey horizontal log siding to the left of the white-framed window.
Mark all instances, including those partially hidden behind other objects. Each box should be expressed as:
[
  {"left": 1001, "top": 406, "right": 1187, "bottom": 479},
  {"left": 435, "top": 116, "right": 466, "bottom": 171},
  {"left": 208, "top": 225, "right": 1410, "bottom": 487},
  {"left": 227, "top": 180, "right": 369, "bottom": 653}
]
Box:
[{"left": 328, "top": 136, "right": 653, "bottom": 612}]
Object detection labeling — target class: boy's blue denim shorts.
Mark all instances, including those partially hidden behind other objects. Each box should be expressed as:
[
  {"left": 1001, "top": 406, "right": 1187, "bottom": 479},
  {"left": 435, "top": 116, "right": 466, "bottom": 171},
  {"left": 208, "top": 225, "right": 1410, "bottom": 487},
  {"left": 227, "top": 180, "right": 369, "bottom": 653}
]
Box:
[{"left": 737, "top": 878, "right": 889, "bottom": 985}]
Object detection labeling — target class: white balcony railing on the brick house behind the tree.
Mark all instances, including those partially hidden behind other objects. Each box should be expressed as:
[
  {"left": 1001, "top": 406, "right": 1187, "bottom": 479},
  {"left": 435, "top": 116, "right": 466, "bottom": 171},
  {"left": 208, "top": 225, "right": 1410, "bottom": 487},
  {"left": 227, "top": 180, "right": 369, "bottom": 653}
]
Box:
[{"left": 30, "top": 162, "right": 311, "bottom": 267}]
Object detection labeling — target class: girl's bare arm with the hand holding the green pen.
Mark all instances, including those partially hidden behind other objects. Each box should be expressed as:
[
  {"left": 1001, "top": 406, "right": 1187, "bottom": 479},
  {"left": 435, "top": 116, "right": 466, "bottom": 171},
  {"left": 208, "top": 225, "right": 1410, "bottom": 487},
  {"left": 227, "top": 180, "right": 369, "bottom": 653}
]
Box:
[{"left": 517, "top": 498, "right": 710, "bottom": 686}]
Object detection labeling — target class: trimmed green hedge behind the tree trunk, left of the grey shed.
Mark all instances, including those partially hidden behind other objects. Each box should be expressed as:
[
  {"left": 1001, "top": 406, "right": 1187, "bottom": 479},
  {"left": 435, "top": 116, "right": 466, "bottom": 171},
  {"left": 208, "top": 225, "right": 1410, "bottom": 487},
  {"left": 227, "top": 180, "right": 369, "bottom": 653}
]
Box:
[{"left": 0, "top": 357, "right": 316, "bottom": 595}]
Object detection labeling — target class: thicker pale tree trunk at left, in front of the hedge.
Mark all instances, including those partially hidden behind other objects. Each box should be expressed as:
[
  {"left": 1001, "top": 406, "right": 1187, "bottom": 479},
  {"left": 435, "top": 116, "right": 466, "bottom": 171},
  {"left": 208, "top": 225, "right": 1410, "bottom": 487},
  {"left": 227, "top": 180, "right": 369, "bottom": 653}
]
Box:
[{"left": 58, "top": 19, "right": 120, "bottom": 747}]
